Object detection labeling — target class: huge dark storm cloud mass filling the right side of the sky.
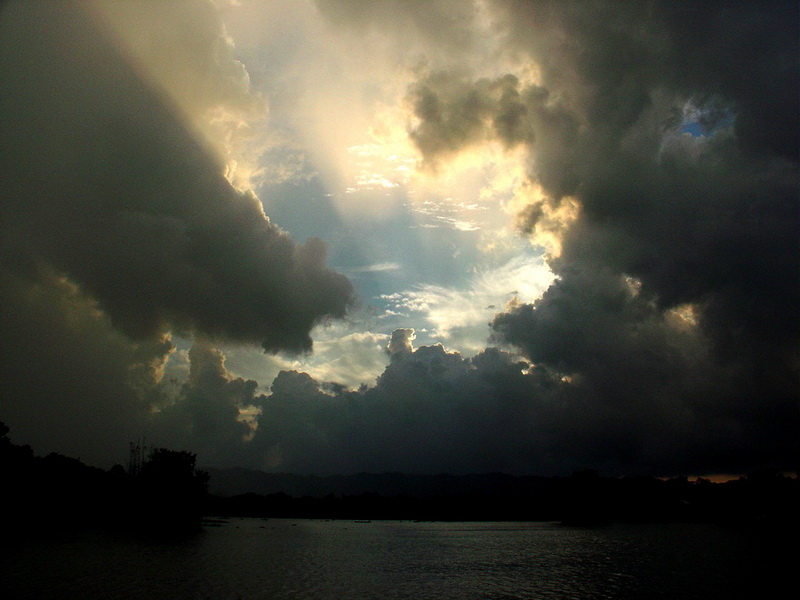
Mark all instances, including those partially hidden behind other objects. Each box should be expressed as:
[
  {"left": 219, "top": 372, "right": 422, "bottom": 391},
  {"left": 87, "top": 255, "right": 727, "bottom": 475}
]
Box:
[{"left": 482, "top": 3, "right": 800, "bottom": 468}]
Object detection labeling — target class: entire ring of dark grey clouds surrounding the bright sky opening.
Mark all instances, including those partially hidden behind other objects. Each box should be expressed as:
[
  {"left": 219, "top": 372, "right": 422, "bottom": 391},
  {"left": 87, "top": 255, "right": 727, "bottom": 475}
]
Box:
[{"left": 0, "top": 1, "right": 800, "bottom": 474}]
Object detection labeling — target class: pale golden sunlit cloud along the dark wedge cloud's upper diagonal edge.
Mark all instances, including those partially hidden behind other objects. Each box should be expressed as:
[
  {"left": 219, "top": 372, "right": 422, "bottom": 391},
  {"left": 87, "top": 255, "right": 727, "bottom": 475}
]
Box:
[{"left": 87, "top": 0, "right": 268, "bottom": 191}]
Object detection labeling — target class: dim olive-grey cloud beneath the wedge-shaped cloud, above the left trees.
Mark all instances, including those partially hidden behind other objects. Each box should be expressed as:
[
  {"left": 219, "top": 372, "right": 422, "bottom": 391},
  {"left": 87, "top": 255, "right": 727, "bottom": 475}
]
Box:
[{"left": 0, "top": 264, "right": 161, "bottom": 466}]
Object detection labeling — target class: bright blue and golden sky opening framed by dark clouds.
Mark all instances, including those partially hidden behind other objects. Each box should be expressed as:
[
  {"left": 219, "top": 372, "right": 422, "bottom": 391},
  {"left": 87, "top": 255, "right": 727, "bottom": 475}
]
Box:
[{"left": 195, "top": 2, "right": 552, "bottom": 387}]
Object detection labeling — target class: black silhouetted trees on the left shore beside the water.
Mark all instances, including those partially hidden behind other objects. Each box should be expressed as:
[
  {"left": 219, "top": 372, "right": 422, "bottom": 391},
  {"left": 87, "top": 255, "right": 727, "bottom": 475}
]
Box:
[{"left": 0, "top": 422, "right": 208, "bottom": 533}]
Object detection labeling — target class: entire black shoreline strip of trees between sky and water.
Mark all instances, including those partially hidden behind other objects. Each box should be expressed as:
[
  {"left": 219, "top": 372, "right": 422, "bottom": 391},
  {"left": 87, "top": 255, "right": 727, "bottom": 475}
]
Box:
[{"left": 0, "top": 423, "right": 800, "bottom": 533}]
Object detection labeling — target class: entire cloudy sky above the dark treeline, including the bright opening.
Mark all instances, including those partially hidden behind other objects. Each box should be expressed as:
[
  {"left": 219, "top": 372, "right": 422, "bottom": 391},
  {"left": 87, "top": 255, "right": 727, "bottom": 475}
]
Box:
[{"left": 0, "top": 0, "right": 800, "bottom": 476}]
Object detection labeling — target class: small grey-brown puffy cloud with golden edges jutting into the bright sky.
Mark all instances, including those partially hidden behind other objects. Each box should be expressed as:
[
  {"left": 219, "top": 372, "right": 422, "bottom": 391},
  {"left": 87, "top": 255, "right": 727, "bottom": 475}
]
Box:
[{"left": 408, "top": 71, "right": 583, "bottom": 256}]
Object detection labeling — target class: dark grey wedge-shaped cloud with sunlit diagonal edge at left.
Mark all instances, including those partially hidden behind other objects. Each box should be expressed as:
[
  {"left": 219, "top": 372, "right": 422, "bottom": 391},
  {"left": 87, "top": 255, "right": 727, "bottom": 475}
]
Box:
[{"left": 1, "top": 5, "right": 352, "bottom": 351}]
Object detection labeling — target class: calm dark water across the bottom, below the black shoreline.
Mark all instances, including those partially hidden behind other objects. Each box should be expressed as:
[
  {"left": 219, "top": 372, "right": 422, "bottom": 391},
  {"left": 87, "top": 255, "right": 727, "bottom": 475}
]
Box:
[{"left": 0, "top": 519, "right": 781, "bottom": 600}]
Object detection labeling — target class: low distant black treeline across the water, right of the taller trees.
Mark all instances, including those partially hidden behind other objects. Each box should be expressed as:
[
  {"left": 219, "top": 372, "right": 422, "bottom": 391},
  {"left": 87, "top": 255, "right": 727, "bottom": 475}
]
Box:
[{"left": 209, "top": 470, "right": 800, "bottom": 526}]
